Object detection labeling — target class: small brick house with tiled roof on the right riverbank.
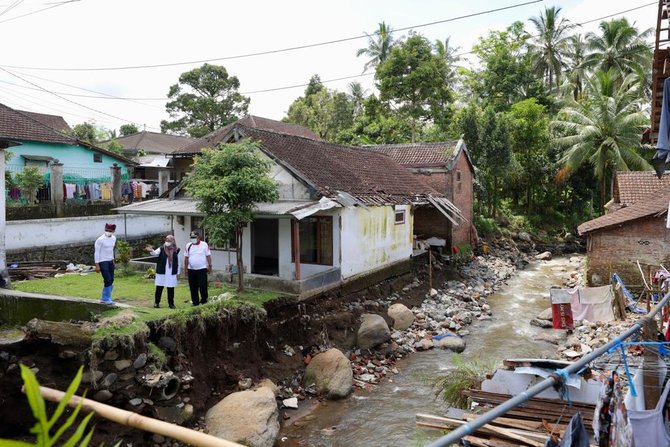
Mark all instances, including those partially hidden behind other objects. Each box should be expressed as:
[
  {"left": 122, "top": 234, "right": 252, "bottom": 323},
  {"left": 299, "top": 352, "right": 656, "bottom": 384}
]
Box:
[{"left": 577, "top": 171, "right": 670, "bottom": 285}]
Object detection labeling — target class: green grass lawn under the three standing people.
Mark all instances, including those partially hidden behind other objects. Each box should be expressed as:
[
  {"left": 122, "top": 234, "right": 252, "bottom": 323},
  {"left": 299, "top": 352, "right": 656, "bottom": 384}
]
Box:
[{"left": 13, "top": 270, "right": 281, "bottom": 313}]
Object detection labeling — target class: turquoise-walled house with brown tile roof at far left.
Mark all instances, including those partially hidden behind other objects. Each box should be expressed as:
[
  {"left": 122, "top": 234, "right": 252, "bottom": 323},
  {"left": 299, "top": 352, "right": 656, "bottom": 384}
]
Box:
[{"left": 0, "top": 104, "right": 135, "bottom": 202}]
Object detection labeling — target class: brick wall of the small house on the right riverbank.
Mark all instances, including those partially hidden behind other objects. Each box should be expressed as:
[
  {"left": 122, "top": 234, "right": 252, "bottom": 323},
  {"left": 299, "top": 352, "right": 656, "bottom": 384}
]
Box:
[{"left": 586, "top": 216, "right": 670, "bottom": 284}]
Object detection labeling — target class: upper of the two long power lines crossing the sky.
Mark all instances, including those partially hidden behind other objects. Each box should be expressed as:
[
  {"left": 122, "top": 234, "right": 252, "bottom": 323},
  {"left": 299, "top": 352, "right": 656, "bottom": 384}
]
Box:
[{"left": 0, "top": 0, "right": 544, "bottom": 71}]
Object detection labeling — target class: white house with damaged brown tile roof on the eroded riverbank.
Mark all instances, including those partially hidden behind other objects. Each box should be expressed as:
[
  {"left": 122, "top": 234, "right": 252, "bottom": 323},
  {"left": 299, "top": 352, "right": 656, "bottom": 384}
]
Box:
[{"left": 118, "top": 119, "right": 464, "bottom": 297}]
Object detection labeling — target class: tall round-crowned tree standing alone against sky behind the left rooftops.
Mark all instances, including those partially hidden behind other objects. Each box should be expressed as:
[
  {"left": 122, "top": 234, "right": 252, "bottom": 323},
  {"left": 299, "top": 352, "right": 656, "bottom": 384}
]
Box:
[{"left": 161, "top": 64, "right": 249, "bottom": 138}]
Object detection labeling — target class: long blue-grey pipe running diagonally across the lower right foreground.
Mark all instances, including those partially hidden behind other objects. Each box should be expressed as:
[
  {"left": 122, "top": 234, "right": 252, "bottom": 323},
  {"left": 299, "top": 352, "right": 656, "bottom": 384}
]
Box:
[{"left": 428, "top": 292, "right": 670, "bottom": 447}]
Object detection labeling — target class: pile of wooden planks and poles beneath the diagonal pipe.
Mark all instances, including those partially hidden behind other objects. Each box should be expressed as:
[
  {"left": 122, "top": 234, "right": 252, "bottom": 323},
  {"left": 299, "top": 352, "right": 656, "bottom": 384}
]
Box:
[{"left": 416, "top": 389, "right": 595, "bottom": 447}]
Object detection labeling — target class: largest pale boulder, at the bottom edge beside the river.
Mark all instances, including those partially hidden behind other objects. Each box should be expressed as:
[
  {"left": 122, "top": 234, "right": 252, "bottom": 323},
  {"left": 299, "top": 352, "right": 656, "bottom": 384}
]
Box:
[{"left": 205, "top": 387, "right": 279, "bottom": 447}]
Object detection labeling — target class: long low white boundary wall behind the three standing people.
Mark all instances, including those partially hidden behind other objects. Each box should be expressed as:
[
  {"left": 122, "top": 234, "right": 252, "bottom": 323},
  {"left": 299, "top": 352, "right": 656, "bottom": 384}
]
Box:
[{"left": 3, "top": 214, "right": 170, "bottom": 250}]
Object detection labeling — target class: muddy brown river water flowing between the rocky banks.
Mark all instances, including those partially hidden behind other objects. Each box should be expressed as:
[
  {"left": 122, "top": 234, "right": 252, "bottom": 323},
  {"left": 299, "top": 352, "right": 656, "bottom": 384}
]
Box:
[{"left": 276, "top": 258, "right": 575, "bottom": 447}]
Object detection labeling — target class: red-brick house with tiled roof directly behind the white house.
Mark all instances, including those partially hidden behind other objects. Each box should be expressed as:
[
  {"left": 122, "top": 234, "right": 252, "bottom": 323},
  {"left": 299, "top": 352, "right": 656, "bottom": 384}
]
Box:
[{"left": 364, "top": 139, "right": 477, "bottom": 247}]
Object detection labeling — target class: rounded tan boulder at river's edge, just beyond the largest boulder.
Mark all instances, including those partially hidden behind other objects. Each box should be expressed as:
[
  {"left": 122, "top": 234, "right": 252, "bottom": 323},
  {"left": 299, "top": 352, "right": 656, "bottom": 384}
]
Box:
[{"left": 304, "top": 348, "right": 354, "bottom": 399}]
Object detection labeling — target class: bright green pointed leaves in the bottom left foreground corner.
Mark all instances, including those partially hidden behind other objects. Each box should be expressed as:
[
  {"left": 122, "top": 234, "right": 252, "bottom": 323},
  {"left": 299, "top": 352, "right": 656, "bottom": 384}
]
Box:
[{"left": 0, "top": 365, "right": 94, "bottom": 447}]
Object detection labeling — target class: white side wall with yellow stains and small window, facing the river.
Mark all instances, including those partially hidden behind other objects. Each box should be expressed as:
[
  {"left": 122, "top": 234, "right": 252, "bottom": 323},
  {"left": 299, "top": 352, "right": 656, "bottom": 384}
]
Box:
[{"left": 340, "top": 205, "right": 414, "bottom": 279}]
